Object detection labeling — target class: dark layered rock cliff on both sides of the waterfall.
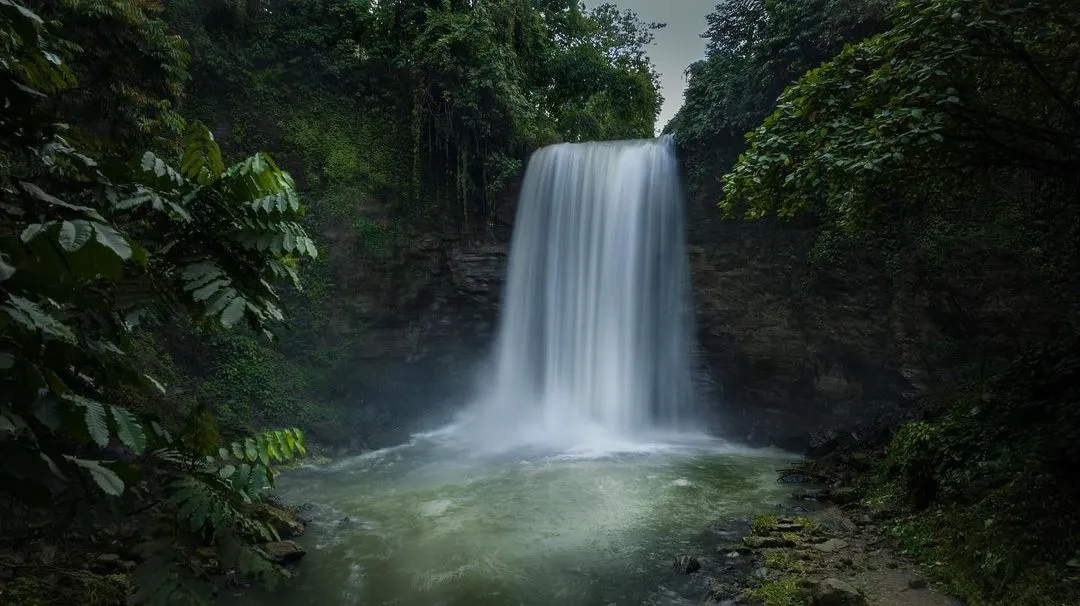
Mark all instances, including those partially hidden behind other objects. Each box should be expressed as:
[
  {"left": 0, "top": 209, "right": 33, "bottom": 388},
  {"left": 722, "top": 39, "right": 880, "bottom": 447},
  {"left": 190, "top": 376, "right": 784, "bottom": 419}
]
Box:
[{"left": 339, "top": 176, "right": 1075, "bottom": 450}]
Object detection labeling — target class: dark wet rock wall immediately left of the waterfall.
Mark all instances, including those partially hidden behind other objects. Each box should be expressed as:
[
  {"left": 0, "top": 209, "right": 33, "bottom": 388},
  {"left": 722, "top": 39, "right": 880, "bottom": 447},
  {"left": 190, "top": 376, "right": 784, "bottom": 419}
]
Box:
[{"left": 300, "top": 218, "right": 508, "bottom": 450}]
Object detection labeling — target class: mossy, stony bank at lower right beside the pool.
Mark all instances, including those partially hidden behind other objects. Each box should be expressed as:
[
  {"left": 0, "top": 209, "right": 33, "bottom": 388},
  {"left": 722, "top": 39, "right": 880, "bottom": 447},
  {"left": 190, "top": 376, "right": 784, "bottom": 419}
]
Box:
[{"left": 673, "top": 458, "right": 961, "bottom": 606}]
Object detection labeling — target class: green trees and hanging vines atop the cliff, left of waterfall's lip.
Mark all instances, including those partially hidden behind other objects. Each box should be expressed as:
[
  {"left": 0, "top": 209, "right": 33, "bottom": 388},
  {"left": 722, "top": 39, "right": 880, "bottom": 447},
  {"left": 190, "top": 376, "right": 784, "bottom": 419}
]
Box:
[{"left": 166, "top": 0, "right": 661, "bottom": 234}]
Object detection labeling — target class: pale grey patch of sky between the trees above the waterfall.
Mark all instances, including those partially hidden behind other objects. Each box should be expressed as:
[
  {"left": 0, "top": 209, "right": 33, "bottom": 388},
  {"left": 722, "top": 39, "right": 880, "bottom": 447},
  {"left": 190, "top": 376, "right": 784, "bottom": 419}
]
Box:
[{"left": 585, "top": 0, "right": 718, "bottom": 132}]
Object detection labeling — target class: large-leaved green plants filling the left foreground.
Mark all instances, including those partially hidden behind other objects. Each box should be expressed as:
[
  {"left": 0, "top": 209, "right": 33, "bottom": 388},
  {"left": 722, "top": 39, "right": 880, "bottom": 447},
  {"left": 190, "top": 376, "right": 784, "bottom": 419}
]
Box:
[{"left": 0, "top": 0, "right": 316, "bottom": 604}]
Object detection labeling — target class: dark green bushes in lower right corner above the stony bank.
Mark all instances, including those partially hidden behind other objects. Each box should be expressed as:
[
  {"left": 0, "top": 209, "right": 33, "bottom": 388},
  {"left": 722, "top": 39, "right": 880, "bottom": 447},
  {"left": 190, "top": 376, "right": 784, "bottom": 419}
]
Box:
[{"left": 877, "top": 342, "right": 1080, "bottom": 605}]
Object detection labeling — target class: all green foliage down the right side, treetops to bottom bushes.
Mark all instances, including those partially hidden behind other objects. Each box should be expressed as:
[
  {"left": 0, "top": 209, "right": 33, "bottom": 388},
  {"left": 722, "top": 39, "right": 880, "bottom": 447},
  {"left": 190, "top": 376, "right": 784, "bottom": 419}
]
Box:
[{"left": 673, "top": 0, "right": 1080, "bottom": 604}]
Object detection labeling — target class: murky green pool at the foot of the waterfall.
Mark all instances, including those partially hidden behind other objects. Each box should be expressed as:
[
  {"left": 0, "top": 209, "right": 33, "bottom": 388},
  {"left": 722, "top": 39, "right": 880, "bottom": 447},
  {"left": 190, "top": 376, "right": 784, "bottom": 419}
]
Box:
[{"left": 238, "top": 435, "right": 789, "bottom": 606}]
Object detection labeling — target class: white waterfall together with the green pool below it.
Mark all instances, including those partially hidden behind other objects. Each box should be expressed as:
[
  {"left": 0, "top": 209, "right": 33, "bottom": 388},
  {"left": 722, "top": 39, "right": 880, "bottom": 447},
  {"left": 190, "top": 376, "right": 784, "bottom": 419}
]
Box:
[{"left": 232, "top": 140, "right": 791, "bottom": 606}]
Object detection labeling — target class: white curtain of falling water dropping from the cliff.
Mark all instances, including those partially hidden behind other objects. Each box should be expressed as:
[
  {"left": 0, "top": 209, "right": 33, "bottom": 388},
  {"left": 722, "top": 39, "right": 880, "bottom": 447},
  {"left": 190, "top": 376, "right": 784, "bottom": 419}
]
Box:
[{"left": 459, "top": 137, "right": 692, "bottom": 450}]
